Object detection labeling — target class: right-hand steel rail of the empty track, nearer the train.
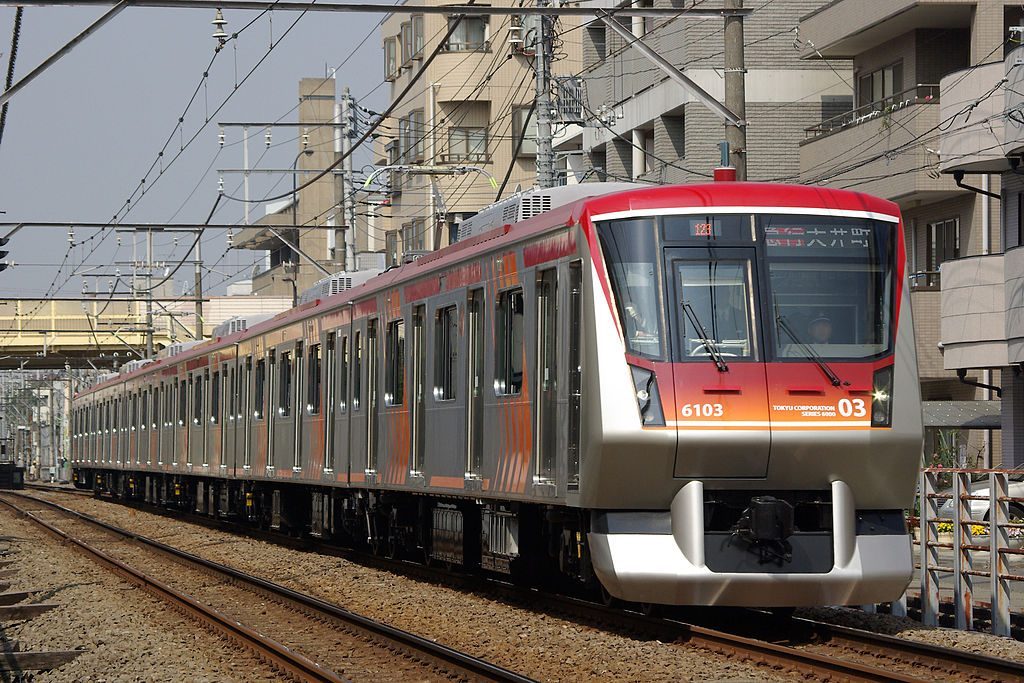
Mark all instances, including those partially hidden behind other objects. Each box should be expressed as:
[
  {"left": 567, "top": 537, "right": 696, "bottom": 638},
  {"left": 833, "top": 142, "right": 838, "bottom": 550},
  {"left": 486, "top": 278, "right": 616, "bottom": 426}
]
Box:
[{"left": 8, "top": 487, "right": 534, "bottom": 683}]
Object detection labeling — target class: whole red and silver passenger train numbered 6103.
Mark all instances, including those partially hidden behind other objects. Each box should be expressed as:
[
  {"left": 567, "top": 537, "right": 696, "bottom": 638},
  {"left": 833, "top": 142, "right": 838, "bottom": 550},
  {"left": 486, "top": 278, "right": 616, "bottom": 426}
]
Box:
[{"left": 73, "top": 182, "right": 922, "bottom": 606}]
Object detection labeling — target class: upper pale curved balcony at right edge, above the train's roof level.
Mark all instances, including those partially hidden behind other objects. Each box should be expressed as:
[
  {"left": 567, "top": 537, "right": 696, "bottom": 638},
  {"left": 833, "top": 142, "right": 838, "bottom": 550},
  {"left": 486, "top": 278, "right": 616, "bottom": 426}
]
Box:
[{"left": 939, "top": 61, "right": 1007, "bottom": 173}]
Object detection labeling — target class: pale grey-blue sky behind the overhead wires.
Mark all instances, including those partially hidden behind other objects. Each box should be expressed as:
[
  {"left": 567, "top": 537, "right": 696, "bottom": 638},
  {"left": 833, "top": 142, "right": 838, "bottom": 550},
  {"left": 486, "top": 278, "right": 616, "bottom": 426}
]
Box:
[{"left": 0, "top": 7, "right": 387, "bottom": 298}]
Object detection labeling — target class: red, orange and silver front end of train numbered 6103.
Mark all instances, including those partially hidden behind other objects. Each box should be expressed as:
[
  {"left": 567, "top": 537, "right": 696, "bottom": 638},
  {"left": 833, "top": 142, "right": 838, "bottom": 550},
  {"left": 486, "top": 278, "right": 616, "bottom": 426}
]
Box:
[{"left": 581, "top": 183, "right": 922, "bottom": 606}]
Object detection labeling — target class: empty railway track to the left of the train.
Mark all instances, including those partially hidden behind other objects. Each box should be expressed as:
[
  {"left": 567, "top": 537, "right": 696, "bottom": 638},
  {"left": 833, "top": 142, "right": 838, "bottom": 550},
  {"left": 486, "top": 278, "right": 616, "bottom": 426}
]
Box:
[{"left": 0, "top": 492, "right": 531, "bottom": 683}]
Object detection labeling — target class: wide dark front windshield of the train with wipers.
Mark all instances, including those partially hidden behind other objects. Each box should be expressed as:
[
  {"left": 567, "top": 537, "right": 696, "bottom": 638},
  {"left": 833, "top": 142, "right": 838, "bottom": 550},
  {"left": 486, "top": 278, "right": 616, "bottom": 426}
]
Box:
[{"left": 598, "top": 214, "right": 896, "bottom": 362}]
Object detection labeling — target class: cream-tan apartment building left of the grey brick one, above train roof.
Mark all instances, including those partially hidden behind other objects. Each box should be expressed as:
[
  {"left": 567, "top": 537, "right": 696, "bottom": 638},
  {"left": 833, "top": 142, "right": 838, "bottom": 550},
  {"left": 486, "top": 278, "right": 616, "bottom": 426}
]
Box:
[{"left": 377, "top": 0, "right": 581, "bottom": 264}]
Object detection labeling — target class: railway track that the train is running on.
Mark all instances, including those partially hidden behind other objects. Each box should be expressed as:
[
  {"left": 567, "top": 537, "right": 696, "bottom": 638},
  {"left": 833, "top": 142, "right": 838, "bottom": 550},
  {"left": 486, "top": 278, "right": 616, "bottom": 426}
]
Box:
[{"left": 22, "top": 487, "right": 1024, "bottom": 682}]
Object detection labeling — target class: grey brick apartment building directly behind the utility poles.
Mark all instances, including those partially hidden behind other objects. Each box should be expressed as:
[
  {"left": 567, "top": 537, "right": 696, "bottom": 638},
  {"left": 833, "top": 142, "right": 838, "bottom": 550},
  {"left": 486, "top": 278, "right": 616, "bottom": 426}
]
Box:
[{"left": 582, "top": 0, "right": 852, "bottom": 183}]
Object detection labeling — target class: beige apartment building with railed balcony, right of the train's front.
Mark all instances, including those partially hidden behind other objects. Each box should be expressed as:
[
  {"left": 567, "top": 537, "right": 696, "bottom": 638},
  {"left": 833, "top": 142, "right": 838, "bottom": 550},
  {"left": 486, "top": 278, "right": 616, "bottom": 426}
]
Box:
[{"left": 800, "top": 0, "right": 1021, "bottom": 464}]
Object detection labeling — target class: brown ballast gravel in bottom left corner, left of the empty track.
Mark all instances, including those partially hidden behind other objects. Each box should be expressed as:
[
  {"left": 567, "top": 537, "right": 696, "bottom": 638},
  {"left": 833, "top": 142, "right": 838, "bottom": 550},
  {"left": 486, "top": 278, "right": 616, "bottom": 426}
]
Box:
[{"left": 0, "top": 506, "right": 282, "bottom": 683}]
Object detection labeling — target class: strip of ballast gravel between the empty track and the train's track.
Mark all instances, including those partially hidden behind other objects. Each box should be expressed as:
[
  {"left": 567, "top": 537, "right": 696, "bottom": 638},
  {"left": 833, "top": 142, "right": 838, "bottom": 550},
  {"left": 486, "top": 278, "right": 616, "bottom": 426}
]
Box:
[{"left": 39, "top": 495, "right": 797, "bottom": 681}]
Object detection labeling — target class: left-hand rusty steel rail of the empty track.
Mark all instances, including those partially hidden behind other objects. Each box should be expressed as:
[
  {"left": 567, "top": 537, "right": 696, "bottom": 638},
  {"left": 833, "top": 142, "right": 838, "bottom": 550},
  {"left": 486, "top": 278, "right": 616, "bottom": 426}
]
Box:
[{"left": 0, "top": 492, "right": 345, "bottom": 683}]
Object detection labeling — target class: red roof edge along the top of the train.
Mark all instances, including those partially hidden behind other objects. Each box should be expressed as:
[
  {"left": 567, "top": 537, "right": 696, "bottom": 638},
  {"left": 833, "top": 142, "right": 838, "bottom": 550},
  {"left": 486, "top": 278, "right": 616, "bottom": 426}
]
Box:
[{"left": 77, "top": 182, "right": 900, "bottom": 393}]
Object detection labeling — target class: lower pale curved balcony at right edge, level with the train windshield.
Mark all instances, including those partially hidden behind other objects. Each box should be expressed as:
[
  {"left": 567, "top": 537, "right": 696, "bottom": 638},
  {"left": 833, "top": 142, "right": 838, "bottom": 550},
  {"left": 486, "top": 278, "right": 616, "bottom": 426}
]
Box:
[{"left": 939, "top": 253, "right": 1003, "bottom": 370}]
